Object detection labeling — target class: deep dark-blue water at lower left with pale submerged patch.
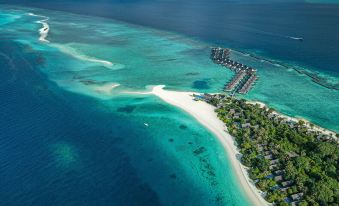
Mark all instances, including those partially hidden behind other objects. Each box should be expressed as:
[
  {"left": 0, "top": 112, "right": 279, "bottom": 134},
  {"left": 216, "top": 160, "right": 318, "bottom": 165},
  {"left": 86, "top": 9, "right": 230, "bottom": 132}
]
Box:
[{"left": 0, "top": 41, "right": 160, "bottom": 205}]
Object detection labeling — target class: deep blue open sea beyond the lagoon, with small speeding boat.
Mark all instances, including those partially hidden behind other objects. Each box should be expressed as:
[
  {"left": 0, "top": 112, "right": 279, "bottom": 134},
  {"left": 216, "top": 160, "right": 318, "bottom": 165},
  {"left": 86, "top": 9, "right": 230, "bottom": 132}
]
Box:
[{"left": 0, "top": 0, "right": 339, "bottom": 77}]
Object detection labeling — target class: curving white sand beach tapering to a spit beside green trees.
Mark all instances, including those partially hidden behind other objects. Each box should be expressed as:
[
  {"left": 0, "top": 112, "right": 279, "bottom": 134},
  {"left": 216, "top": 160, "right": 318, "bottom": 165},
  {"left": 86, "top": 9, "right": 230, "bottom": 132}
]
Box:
[{"left": 152, "top": 85, "right": 268, "bottom": 205}]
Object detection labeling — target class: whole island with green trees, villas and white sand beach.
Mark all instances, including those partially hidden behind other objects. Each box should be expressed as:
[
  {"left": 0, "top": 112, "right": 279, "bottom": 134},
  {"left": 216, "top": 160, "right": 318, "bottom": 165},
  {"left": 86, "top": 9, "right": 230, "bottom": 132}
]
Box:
[{"left": 150, "top": 85, "right": 339, "bottom": 205}]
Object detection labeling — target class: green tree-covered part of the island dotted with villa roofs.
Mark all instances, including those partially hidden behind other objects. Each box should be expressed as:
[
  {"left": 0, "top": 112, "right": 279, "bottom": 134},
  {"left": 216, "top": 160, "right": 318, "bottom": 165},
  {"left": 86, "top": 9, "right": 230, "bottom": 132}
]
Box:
[{"left": 203, "top": 94, "right": 339, "bottom": 205}]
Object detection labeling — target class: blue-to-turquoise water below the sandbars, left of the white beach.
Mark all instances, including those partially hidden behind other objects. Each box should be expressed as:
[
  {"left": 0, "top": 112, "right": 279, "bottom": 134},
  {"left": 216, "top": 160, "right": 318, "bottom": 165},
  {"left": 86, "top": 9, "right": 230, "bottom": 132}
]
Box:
[{"left": 0, "top": 31, "right": 249, "bottom": 206}]
